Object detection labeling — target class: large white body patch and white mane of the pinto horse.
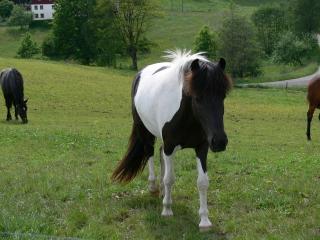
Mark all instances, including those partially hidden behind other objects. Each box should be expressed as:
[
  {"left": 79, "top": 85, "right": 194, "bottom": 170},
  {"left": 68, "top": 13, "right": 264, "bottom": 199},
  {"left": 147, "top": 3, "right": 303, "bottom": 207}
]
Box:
[{"left": 134, "top": 51, "right": 208, "bottom": 139}]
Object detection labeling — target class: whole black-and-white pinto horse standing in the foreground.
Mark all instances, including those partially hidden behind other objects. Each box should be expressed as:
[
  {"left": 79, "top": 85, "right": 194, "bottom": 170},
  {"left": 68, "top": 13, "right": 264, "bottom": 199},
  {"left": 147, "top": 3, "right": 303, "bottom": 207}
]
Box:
[{"left": 112, "top": 51, "right": 231, "bottom": 229}]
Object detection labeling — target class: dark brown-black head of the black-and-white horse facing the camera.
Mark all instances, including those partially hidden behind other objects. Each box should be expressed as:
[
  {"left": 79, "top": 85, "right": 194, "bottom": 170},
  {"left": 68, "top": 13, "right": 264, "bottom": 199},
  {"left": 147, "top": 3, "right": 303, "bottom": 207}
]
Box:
[{"left": 184, "top": 59, "right": 231, "bottom": 152}]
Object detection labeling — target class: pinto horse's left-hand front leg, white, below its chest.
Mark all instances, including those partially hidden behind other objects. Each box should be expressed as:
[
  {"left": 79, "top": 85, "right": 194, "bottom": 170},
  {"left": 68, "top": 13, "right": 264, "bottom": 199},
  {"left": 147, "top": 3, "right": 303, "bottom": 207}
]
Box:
[{"left": 161, "top": 145, "right": 179, "bottom": 216}]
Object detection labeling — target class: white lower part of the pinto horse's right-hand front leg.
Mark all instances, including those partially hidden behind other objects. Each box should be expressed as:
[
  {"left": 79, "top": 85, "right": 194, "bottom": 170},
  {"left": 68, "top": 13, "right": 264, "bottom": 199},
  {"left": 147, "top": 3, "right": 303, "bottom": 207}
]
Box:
[{"left": 197, "top": 158, "right": 212, "bottom": 229}]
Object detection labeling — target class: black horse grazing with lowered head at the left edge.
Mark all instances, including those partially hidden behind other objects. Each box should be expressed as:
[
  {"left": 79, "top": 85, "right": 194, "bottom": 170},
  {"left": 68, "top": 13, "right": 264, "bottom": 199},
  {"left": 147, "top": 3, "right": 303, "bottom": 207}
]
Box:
[{"left": 0, "top": 68, "right": 28, "bottom": 123}]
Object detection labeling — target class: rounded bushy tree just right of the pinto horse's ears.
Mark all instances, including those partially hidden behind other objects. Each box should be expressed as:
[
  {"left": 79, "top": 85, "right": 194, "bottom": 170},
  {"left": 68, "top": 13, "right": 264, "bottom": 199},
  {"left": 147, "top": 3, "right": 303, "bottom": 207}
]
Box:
[{"left": 219, "top": 9, "right": 260, "bottom": 77}]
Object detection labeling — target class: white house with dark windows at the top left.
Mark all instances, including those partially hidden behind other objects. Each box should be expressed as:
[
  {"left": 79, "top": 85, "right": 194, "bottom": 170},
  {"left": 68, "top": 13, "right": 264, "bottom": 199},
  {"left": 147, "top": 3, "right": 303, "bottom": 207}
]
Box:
[{"left": 31, "top": 0, "right": 54, "bottom": 21}]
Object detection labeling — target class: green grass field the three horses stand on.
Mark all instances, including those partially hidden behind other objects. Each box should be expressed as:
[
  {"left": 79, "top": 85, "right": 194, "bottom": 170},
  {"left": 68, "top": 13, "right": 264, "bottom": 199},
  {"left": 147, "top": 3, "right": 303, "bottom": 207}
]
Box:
[{"left": 0, "top": 58, "right": 320, "bottom": 239}]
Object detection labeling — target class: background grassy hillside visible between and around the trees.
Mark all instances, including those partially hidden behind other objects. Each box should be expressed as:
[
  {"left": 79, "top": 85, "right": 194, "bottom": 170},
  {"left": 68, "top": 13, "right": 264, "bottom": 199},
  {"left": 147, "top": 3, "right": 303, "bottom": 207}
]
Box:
[{"left": 0, "top": 0, "right": 317, "bottom": 82}]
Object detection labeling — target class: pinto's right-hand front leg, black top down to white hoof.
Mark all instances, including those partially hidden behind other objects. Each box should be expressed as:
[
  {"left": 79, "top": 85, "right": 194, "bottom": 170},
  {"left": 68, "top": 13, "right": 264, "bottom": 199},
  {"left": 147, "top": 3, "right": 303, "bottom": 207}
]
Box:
[{"left": 196, "top": 144, "right": 212, "bottom": 231}]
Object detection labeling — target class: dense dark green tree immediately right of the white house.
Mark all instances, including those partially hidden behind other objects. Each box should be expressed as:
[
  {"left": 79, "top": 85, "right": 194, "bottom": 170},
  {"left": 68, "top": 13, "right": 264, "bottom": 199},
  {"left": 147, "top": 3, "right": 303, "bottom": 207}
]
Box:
[{"left": 53, "top": 0, "right": 95, "bottom": 64}]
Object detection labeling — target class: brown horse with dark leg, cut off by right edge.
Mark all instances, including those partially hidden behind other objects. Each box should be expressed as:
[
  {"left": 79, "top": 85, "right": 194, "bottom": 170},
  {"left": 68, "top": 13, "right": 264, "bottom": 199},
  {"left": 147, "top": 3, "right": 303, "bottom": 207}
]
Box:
[{"left": 307, "top": 75, "right": 320, "bottom": 140}]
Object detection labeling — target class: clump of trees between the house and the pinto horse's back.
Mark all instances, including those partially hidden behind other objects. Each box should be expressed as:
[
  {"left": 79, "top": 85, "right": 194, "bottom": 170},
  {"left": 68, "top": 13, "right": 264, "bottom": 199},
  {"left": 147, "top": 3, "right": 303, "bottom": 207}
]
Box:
[{"left": 43, "top": 0, "right": 158, "bottom": 69}]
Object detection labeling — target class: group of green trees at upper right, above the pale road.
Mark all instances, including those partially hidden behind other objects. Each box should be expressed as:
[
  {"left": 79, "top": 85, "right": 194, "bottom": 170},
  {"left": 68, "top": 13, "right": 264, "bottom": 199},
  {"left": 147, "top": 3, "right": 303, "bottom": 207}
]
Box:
[{"left": 194, "top": 0, "right": 320, "bottom": 77}]
